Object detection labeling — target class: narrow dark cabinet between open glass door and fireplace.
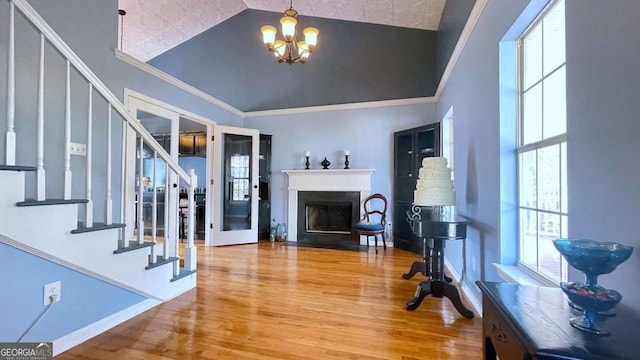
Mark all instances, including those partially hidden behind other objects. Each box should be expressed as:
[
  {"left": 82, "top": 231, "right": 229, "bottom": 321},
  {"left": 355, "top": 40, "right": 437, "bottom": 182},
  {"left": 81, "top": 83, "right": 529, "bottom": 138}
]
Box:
[{"left": 258, "top": 134, "right": 271, "bottom": 240}]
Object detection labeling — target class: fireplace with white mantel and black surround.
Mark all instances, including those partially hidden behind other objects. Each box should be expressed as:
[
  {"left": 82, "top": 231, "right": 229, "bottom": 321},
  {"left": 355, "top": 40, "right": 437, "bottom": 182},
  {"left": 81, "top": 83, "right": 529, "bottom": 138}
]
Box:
[{"left": 282, "top": 169, "right": 375, "bottom": 245}]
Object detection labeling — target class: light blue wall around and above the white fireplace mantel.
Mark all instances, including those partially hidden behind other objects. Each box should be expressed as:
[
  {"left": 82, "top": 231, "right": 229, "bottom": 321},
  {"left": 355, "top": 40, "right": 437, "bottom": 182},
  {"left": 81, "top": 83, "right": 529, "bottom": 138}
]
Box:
[{"left": 245, "top": 103, "right": 438, "bottom": 222}]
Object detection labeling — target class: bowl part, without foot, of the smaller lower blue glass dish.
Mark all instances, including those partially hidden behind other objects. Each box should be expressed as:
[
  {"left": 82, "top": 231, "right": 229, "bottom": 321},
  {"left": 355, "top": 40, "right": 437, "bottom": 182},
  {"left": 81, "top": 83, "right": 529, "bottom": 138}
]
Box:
[{"left": 560, "top": 281, "right": 622, "bottom": 312}]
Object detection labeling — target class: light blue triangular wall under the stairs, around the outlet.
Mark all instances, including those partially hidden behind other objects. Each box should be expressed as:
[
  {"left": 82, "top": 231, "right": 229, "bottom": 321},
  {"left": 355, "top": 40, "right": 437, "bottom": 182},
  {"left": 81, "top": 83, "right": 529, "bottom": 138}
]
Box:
[{"left": 0, "top": 242, "right": 146, "bottom": 342}]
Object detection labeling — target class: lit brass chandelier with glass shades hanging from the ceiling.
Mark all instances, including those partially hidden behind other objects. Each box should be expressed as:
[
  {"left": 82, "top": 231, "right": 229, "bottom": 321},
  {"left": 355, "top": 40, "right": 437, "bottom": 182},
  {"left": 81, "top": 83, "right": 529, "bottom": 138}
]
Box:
[{"left": 260, "top": 0, "right": 319, "bottom": 65}]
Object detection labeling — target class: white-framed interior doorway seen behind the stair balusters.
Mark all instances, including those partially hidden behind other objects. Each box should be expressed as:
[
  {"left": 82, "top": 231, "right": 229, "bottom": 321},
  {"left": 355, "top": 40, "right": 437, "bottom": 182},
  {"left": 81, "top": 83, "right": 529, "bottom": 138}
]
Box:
[{"left": 125, "top": 90, "right": 215, "bottom": 245}]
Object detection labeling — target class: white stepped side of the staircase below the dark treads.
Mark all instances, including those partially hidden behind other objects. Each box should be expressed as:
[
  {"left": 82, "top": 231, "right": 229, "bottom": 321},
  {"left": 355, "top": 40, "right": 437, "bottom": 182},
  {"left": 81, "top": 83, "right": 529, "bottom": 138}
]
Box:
[{"left": 0, "top": 171, "right": 196, "bottom": 300}]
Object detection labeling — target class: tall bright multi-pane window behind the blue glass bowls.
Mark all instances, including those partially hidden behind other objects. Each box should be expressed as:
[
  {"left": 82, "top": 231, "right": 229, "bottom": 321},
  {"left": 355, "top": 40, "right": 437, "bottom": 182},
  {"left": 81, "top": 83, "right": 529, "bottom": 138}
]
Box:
[{"left": 517, "top": 0, "right": 569, "bottom": 283}]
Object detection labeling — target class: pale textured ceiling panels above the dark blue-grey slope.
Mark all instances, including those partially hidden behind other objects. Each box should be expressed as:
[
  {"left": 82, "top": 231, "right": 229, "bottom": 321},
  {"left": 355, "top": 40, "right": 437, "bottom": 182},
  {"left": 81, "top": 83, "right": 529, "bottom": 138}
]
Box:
[{"left": 119, "top": 0, "right": 446, "bottom": 61}]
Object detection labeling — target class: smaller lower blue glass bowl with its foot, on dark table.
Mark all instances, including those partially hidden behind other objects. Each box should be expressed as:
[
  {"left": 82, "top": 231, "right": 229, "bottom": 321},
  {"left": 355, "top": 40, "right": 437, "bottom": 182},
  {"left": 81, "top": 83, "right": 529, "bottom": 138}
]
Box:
[{"left": 560, "top": 281, "right": 622, "bottom": 335}]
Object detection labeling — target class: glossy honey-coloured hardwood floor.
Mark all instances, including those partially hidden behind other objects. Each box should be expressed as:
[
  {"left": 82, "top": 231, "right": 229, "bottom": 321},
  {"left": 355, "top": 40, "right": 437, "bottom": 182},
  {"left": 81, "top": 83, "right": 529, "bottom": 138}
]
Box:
[{"left": 56, "top": 242, "right": 482, "bottom": 360}]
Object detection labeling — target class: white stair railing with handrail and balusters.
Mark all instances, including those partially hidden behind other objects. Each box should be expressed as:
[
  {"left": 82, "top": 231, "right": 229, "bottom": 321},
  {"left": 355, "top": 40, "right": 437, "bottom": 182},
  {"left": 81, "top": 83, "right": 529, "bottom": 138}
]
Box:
[{"left": 5, "top": 0, "right": 197, "bottom": 276}]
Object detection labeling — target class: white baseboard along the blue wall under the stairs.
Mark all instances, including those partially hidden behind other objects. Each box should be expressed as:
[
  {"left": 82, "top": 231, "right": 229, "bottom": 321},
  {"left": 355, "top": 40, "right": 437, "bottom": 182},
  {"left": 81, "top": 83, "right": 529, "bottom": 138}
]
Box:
[{"left": 53, "top": 299, "right": 161, "bottom": 356}]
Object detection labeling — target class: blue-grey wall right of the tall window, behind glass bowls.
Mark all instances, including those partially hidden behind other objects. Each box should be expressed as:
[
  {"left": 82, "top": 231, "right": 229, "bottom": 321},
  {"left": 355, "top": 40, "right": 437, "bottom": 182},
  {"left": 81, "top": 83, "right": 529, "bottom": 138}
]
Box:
[{"left": 566, "top": 0, "right": 640, "bottom": 311}]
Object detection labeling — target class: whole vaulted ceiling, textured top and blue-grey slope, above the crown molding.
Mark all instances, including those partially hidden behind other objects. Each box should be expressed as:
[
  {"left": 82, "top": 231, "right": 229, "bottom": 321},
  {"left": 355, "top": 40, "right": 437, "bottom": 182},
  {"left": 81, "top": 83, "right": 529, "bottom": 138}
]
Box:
[{"left": 118, "top": 0, "right": 475, "bottom": 112}]
